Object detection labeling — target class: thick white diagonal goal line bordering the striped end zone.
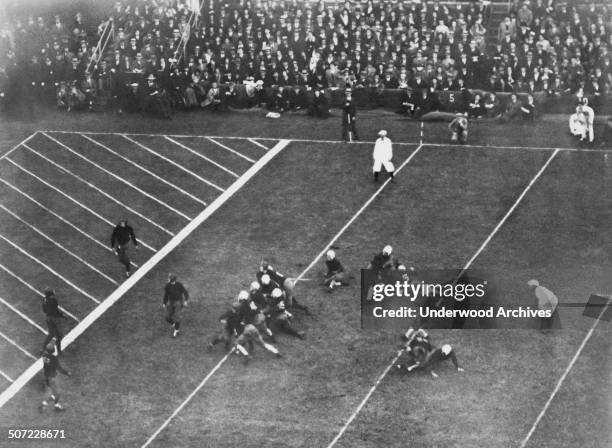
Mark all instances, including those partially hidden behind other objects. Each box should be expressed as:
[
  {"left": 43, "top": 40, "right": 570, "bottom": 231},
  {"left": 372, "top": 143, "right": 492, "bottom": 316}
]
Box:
[{"left": 0, "top": 140, "right": 290, "bottom": 408}]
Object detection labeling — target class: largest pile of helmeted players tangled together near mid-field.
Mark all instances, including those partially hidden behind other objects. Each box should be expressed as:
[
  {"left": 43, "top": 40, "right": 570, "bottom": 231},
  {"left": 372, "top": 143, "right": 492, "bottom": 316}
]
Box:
[{"left": 208, "top": 261, "right": 310, "bottom": 363}]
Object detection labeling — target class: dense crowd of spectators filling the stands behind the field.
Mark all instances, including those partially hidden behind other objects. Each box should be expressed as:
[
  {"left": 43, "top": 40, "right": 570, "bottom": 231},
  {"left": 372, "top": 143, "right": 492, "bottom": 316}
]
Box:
[{"left": 0, "top": 0, "right": 612, "bottom": 116}]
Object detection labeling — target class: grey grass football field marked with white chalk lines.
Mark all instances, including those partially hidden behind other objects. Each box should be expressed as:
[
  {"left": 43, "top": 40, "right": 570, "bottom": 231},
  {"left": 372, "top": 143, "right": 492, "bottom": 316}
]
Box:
[{"left": 0, "top": 108, "right": 612, "bottom": 448}]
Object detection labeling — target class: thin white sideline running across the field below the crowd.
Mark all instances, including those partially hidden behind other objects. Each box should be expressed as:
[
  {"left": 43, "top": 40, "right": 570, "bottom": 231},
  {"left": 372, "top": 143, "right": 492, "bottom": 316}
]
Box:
[{"left": 44, "top": 131, "right": 612, "bottom": 153}]
